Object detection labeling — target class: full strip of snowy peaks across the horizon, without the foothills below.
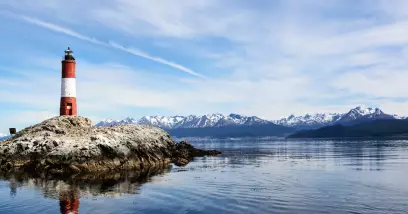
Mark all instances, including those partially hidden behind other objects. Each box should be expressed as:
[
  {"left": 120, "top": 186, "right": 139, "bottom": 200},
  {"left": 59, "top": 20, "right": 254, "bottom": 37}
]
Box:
[{"left": 96, "top": 106, "right": 404, "bottom": 130}]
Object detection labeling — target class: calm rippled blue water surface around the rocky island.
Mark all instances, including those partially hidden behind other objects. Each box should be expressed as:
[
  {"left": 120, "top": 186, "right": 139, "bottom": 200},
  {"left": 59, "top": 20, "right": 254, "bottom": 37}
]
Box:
[{"left": 0, "top": 140, "right": 408, "bottom": 214}]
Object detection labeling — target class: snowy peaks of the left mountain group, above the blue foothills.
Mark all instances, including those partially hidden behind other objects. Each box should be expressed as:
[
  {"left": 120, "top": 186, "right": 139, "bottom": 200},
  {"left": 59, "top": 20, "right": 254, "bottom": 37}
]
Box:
[{"left": 96, "top": 114, "right": 272, "bottom": 129}]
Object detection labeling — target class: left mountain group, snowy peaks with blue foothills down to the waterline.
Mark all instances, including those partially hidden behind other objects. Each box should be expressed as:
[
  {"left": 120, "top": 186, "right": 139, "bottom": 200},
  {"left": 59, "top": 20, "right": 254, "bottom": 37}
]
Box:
[{"left": 96, "top": 114, "right": 295, "bottom": 138}]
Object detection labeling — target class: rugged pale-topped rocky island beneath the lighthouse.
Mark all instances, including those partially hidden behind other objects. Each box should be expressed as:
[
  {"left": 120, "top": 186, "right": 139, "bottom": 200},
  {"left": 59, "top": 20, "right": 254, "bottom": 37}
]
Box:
[{"left": 0, "top": 116, "right": 220, "bottom": 174}]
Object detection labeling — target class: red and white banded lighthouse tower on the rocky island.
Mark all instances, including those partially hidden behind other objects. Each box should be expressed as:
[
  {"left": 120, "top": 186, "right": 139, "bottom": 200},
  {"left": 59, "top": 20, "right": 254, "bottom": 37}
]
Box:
[{"left": 60, "top": 47, "right": 77, "bottom": 116}]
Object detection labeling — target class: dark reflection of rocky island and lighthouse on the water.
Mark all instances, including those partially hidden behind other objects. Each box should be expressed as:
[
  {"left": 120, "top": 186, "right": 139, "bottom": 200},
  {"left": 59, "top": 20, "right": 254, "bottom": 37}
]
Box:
[{"left": 0, "top": 166, "right": 171, "bottom": 214}]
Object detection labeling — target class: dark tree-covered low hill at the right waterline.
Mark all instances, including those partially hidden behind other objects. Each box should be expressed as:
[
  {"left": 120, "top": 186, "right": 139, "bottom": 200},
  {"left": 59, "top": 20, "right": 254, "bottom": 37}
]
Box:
[{"left": 288, "top": 119, "right": 408, "bottom": 138}]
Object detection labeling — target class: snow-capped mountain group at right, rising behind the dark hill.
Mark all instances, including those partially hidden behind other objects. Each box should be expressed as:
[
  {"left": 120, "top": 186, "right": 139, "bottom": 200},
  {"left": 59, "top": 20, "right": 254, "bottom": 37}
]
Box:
[{"left": 274, "top": 106, "right": 406, "bottom": 129}]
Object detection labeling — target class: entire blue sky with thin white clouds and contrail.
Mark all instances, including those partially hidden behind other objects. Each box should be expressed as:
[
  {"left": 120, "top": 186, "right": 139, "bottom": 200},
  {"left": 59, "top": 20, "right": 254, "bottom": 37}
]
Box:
[{"left": 0, "top": 0, "right": 408, "bottom": 133}]
